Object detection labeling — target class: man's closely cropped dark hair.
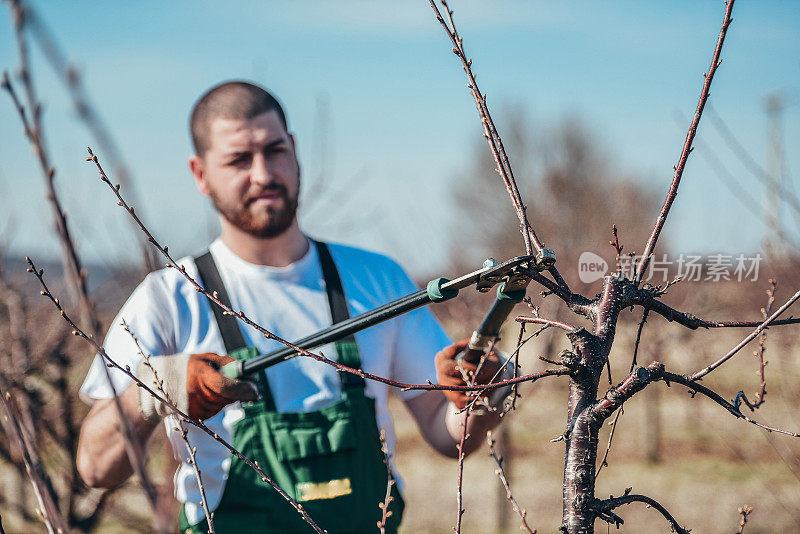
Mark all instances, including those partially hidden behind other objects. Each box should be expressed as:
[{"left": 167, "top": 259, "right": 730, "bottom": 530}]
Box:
[{"left": 189, "top": 80, "right": 288, "bottom": 157}]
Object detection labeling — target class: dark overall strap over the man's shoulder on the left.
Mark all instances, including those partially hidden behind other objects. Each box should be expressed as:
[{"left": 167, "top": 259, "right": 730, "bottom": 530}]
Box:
[{"left": 194, "top": 251, "right": 275, "bottom": 411}]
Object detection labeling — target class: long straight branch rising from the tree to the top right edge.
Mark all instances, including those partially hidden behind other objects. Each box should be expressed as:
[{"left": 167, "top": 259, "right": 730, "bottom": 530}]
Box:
[{"left": 635, "top": 0, "right": 734, "bottom": 282}]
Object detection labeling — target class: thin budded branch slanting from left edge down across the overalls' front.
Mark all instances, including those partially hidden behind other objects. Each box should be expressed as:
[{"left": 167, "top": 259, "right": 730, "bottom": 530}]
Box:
[{"left": 26, "top": 258, "right": 324, "bottom": 534}]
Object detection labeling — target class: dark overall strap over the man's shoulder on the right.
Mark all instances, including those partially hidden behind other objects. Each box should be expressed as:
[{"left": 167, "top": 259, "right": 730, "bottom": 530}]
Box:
[{"left": 314, "top": 241, "right": 364, "bottom": 389}]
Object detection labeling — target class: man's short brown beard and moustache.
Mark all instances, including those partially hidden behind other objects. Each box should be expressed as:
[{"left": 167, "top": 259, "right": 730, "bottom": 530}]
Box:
[{"left": 209, "top": 184, "right": 299, "bottom": 239}]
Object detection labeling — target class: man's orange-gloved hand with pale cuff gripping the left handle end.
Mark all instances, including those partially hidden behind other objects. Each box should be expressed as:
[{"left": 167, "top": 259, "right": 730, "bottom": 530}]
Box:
[{"left": 137, "top": 352, "right": 258, "bottom": 421}]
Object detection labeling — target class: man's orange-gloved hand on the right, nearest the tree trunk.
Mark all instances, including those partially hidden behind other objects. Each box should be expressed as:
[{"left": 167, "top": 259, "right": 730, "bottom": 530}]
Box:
[{"left": 436, "top": 338, "right": 504, "bottom": 410}]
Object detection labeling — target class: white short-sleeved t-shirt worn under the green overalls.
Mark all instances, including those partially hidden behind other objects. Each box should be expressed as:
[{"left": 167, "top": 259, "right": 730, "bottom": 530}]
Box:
[{"left": 81, "top": 239, "right": 450, "bottom": 523}]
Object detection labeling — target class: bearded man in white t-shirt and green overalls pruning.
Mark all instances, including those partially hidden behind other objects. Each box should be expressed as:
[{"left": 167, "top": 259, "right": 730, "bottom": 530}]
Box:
[{"left": 77, "top": 82, "right": 506, "bottom": 533}]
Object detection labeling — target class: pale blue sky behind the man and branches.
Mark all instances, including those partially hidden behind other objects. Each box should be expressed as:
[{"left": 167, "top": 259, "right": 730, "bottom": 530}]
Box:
[{"left": 0, "top": 0, "right": 800, "bottom": 274}]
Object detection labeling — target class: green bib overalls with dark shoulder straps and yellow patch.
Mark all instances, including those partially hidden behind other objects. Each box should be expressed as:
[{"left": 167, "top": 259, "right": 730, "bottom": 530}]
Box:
[{"left": 180, "top": 242, "right": 404, "bottom": 534}]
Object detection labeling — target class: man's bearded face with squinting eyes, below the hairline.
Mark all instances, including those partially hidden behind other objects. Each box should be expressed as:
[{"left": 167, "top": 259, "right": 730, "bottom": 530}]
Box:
[{"left": 190, "top": 111, "right": 300, "bottom": 238}]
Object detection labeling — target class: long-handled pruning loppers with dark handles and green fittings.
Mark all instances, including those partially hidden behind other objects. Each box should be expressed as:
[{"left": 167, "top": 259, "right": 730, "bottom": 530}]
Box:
[{"left": 222, "top": 249, "right": 555, "bottom": 378}]
